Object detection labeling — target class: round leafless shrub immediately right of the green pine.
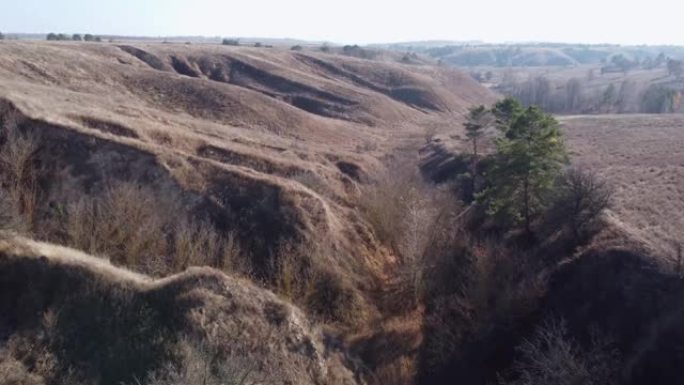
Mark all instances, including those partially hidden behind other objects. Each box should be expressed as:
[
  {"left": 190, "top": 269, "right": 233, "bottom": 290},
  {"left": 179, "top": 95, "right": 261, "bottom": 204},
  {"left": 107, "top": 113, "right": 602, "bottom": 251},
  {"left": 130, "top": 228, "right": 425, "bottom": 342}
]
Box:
[{"left": 550, "top": 168, "right": 613, "bottom": 242}]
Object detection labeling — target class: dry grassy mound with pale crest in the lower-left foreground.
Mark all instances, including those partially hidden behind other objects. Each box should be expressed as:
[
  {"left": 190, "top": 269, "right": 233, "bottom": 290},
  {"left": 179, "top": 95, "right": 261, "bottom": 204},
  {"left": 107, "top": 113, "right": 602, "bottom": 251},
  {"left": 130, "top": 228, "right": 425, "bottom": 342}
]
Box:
[{"left": 0, "top": 235, "right": 354, "bottom": 385}]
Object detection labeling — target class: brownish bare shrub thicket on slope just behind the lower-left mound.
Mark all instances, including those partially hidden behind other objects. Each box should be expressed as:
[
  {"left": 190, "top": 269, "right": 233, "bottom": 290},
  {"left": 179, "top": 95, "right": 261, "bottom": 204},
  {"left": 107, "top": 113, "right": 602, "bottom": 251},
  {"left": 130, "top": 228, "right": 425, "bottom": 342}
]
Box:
[{"left": 65, "top": 183, "right": 251, "bottom": 276}]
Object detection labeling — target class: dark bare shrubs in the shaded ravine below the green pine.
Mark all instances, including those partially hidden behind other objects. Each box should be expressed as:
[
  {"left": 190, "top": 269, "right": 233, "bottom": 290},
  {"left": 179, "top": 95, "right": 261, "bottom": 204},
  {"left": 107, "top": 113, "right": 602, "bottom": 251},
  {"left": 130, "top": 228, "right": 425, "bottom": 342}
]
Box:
[{"left": 423, "top": 238, "right": 545, "bottom": 369}]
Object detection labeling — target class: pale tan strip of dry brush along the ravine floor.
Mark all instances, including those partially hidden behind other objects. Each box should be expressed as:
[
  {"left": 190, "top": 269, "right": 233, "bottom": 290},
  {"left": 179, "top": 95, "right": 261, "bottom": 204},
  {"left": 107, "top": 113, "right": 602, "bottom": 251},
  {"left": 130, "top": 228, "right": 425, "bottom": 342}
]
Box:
[{"left": 355, "top": 156, "right": 462, "bottom": 385}]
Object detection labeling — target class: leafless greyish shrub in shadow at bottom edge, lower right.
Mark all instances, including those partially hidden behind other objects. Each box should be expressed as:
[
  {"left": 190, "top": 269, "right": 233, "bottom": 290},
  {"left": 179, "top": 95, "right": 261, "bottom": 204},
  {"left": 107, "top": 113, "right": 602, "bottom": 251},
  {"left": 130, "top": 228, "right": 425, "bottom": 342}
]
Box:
[{"left": 500, "top": 319, "right": 619, "bottom": 385}]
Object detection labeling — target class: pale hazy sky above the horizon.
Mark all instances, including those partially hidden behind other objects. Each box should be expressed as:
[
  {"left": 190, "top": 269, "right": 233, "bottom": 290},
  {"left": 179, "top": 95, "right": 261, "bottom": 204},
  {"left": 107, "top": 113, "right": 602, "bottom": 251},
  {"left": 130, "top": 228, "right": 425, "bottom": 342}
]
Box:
[{"left": 0, "top": 0, "right": 684, "bottom": 45}]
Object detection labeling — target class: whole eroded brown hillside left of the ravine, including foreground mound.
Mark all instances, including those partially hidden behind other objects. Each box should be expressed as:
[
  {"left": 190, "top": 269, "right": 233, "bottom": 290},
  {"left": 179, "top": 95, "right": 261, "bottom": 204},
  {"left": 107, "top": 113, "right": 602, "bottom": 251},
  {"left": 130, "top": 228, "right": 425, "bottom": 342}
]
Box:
[{"left": 0, "top": 41, "right": 495, "bottom": 384}]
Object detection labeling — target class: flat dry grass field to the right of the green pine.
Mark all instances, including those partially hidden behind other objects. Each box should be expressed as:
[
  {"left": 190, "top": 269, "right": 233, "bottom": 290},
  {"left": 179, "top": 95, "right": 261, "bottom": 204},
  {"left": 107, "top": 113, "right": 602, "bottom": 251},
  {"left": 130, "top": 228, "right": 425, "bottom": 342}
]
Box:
[{"left": 562, "top": 115, "right": 684, "bottom": 260}]
